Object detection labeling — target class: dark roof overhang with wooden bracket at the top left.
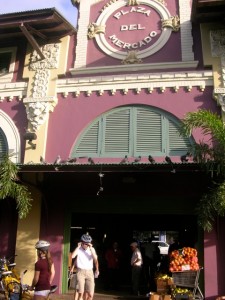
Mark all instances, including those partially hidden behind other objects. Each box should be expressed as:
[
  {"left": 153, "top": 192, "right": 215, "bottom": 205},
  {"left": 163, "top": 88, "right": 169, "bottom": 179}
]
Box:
[{"left": 0, "top": 8, "right": 76, "bottom": 59}]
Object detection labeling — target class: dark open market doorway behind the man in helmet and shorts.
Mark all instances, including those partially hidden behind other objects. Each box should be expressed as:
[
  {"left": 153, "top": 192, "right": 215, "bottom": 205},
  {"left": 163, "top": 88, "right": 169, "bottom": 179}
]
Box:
[{"left": 70, "top": 213, "right": 198, "bottom": 293}]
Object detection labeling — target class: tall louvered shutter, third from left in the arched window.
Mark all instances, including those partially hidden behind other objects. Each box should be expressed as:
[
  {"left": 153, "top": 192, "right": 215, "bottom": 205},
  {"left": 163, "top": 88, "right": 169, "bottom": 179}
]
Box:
[{"left": 135, "top": 108, "right": 162, "bottom": 155}]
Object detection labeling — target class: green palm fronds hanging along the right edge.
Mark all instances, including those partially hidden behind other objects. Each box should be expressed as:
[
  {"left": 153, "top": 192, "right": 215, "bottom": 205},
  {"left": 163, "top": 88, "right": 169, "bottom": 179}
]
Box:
[{"left": 181, "top": 110, "right": 225, "bottom": 231}]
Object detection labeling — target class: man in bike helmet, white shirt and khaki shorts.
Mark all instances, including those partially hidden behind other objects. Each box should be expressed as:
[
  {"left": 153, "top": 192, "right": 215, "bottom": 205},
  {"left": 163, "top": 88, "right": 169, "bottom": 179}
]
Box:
[{"left": 72, "top": 234, "right": 99, "bottom": 300}]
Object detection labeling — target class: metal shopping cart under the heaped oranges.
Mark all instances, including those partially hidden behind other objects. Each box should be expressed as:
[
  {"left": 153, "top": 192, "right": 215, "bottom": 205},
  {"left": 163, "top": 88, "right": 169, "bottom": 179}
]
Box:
[{"left": 172, "top": 268, "right": 204, "bottom": 299}]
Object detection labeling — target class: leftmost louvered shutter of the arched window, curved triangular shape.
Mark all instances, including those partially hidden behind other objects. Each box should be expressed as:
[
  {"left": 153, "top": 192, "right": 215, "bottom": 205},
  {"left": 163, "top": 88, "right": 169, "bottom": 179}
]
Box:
[{"left": 72, "top": 120, "right": 99, "bottom": 157}]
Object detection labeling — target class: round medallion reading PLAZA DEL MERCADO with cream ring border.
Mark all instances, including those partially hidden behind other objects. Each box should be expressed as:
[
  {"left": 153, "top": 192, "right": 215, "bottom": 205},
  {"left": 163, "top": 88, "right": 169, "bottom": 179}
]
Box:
[{"left": 93, "top": 0, "right": 179, "bottom": 63}]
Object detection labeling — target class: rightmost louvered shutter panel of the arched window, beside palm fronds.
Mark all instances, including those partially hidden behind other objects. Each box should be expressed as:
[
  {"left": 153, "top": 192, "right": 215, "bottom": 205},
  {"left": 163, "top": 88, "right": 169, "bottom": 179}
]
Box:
[{"left": 168, "top": 120, "right": 191, "bottom": 155}]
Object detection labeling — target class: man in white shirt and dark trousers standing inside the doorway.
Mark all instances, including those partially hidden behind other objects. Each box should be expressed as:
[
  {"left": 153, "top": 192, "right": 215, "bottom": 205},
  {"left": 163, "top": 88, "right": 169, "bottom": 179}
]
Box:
[{"left": 130, "top": 242, "right": 143, "bottom": 296}]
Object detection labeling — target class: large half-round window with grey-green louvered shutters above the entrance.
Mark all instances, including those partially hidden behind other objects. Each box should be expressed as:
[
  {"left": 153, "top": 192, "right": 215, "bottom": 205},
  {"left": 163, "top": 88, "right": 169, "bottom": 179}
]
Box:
[{"left": 71, "top": 106, "right": 193, "bottom": 157}]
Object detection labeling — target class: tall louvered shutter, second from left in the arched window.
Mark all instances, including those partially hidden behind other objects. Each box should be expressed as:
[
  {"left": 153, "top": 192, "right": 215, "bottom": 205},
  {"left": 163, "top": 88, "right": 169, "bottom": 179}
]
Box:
[{"left": 102, "top": 109, "right": 130, "bottom": 156}]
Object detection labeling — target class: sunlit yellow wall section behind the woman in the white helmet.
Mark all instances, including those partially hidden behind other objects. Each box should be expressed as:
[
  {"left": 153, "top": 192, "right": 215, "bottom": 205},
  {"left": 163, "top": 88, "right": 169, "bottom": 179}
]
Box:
[{"left": 15, "top": 186, "right": 41, "bottom": 284}]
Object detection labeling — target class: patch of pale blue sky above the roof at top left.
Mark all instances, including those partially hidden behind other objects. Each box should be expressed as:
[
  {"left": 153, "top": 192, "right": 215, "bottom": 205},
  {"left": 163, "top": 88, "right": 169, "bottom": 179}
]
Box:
[{"left": 0, "top": 0, "right": 77, "bottom": 27}]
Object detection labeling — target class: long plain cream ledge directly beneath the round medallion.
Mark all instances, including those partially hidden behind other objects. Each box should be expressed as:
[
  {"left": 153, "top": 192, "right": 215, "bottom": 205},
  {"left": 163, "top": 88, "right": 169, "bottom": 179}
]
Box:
[{"left": 70, "top": 60, "right": 198, "bottom": 76}]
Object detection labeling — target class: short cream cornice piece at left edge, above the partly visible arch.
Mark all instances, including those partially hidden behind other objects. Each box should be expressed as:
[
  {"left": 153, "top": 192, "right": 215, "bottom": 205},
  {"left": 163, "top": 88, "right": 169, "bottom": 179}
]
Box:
[{"left": 0, "top": 82, "right": 27, "bottom": 102}]
